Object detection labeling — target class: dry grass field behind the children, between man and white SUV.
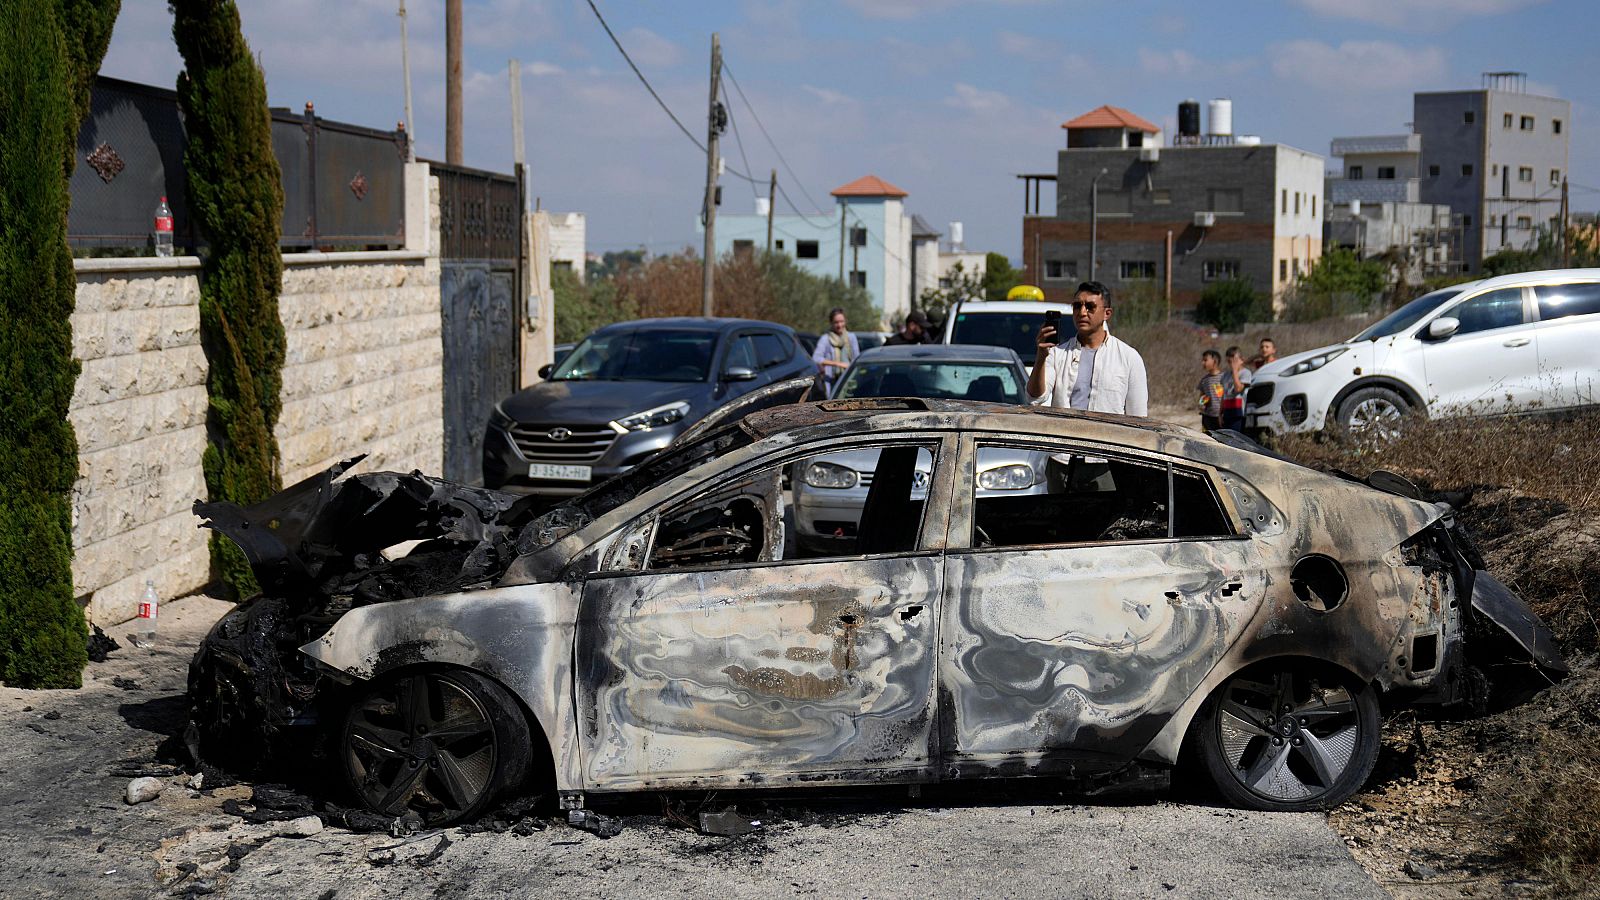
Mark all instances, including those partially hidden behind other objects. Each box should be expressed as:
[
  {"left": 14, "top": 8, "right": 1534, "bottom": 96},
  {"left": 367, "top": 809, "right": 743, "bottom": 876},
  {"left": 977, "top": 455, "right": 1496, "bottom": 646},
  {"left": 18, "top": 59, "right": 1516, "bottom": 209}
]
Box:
[{"left": 1112, "top": 317, "right": 1374, "bottom": 408}]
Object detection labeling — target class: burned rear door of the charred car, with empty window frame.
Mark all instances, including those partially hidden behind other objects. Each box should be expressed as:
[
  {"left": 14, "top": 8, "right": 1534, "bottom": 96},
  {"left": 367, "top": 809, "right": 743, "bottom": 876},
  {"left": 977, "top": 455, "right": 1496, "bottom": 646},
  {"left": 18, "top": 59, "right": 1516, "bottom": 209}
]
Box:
[{"left": 939, "top": 437, "right": 1266, "bottom": 775}]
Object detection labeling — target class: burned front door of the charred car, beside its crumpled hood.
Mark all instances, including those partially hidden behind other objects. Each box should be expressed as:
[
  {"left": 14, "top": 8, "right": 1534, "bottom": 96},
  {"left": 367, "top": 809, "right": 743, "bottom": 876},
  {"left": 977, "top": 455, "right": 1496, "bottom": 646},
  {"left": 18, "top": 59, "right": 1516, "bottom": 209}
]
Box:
[{"left": 574, "top": 434, "right": 954, "bottom": 791}]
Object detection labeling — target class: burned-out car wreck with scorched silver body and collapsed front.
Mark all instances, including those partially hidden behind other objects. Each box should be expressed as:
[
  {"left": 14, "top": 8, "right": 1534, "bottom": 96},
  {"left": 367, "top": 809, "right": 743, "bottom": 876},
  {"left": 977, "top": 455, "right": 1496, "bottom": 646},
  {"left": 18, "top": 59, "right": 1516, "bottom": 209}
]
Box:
[{"left": 190, "top": 399, "right": 1563, "bottom": 823}]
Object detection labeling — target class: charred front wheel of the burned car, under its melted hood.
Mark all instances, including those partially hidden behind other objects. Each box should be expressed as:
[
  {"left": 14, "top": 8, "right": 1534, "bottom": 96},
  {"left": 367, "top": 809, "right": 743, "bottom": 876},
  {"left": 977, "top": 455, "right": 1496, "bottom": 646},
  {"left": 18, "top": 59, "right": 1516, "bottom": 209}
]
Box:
[{"left": 338, "top": 669, "right": 533, "bottom": 826}]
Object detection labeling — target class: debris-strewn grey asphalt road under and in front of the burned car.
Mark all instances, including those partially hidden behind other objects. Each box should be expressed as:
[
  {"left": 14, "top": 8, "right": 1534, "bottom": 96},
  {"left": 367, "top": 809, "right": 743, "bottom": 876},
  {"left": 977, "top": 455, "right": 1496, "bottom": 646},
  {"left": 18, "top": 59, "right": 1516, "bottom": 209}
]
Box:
[{"left": 0, "top": 597, "right": 1386, "bottom": 900}]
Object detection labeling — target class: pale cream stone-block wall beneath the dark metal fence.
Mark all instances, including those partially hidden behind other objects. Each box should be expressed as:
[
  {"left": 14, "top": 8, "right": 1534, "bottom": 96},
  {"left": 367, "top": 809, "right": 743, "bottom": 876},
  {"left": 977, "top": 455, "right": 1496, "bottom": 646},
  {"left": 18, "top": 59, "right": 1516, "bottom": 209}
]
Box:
[{"left": 69, "top": 165, "right": 443, "bottom": 626}]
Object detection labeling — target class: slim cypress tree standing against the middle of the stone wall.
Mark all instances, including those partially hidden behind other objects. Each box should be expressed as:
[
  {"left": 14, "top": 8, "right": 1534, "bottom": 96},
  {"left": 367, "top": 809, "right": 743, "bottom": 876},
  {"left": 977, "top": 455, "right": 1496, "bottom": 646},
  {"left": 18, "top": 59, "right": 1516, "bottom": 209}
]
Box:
[{"left": 170, "top": 0, "right": 285, "bottom": 599}]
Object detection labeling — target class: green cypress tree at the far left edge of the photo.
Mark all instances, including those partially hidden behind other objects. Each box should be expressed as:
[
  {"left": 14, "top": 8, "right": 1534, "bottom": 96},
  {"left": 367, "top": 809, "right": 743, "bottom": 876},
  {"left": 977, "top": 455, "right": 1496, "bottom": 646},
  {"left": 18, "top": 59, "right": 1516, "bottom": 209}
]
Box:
[{"left": 0, "top": 0, "right": 117, "bottom": 687}]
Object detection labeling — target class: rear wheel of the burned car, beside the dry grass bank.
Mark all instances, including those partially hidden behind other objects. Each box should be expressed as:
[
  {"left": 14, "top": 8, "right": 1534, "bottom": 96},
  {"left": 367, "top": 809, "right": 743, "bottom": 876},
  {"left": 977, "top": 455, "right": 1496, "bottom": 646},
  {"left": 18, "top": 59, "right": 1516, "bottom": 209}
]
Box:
[{"left": 1195, "top": 661, "right": 1379, "bottom": 812}]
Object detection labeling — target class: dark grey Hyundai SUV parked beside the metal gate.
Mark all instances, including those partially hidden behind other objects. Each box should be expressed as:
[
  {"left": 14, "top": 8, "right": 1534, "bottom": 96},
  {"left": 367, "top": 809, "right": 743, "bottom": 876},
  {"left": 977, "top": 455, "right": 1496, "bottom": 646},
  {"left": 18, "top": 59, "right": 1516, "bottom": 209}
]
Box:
[{"left": 483, "top": 319, "right": 816, "bottom": 496}]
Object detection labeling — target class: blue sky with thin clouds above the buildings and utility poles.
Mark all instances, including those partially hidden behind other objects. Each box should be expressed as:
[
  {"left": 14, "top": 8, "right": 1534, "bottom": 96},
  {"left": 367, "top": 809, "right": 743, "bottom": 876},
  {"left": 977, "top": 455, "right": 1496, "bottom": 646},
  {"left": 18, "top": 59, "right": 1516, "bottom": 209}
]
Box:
[{"left": 102, "top": 0, "right": 1600, "bottom": 258}]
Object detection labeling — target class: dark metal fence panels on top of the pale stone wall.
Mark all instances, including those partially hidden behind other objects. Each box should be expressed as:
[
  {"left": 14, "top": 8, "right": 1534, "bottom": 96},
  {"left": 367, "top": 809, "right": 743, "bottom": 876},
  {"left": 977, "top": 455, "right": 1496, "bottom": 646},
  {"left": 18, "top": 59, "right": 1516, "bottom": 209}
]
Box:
[{"left": 67, "top": 77, "right": 405, "bottom": 255}]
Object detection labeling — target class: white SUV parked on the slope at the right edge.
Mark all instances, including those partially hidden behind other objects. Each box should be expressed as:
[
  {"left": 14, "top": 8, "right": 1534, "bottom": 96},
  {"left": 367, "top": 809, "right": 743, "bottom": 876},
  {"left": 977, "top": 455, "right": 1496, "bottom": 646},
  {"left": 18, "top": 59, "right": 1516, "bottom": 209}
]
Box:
[{"left": 1245, "top": 269, "right": 1600, "bottom": 434}]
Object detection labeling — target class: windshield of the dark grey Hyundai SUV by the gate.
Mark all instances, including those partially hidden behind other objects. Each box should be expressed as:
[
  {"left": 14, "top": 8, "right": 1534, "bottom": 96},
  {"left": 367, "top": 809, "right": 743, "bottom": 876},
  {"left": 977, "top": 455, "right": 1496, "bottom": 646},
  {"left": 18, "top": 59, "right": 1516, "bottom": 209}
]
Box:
[{"left": 550, "top": 328, "right": 717, "bottom": 381}]
